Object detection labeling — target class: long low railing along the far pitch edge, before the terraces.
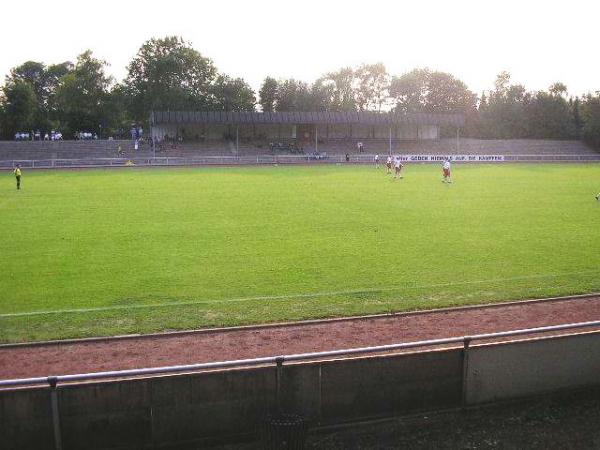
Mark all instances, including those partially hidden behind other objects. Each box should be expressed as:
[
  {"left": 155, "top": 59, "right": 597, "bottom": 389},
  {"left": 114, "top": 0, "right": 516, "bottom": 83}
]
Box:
[{"left": 0, "top": 153, "right": 600, "bottom": 169}]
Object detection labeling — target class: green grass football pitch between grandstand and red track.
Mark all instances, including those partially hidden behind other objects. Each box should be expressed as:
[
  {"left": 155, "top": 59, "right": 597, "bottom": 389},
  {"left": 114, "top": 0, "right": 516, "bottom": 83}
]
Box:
[{"left": 0, "top": 164, "right": 600, "bottom": 342}]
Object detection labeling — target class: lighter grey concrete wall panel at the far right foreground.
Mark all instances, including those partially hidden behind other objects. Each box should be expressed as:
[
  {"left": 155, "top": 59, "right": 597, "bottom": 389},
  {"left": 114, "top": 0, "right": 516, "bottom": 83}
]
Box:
[{"left": 467, "top": 333, "right": 600, "bottom": 404}]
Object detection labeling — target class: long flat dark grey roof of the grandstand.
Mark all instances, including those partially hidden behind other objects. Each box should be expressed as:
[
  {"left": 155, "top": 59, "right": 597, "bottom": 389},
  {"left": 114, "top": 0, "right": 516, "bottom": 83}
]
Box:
[{"left": 151, "top": 111, "right": 465, "bottom": 127}]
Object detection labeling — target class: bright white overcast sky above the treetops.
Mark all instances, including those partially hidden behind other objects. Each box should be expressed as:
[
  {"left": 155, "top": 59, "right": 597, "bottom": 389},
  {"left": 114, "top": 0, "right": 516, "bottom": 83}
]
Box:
[{"left": 0, "top": 0, "right": 600, "bottom": 95}]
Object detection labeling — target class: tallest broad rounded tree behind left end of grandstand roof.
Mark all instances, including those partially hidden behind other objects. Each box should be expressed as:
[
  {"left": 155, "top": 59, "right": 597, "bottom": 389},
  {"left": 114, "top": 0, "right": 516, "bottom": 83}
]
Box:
[{"left": 124, "top": 36, "right": 218, "bottom": 121}]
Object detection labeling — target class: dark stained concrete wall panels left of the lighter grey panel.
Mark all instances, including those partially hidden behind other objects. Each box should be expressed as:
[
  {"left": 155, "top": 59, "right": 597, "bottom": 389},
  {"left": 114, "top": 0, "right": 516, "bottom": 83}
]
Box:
[{"left": 0, "top": 350, "right": 462, "bottom": 450}]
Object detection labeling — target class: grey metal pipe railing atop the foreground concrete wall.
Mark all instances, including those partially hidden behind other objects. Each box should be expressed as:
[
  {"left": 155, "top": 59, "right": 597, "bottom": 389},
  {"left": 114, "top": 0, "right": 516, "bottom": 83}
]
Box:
[{"left": 0, "top": 320, "right": 600, "bottom": 388}]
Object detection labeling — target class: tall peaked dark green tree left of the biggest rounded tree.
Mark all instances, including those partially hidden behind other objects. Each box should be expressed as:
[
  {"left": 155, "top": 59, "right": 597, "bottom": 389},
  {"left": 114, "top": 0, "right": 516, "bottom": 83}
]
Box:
[{"left": 56, "top": 50, "right": 112, "bottom": 135}]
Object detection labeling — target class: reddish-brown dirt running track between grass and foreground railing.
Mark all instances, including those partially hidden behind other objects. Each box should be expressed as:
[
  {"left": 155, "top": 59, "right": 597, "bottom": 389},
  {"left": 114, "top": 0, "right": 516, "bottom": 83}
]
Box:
[{"left": 0, "top": 296, "right": 600, "bottom": 379}]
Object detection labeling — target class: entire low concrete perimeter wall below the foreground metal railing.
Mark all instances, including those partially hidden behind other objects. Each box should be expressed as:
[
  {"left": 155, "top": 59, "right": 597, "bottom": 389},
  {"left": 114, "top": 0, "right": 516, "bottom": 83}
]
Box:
[{"left": 0, "top": 332, "right": 600, "bottom": 450}]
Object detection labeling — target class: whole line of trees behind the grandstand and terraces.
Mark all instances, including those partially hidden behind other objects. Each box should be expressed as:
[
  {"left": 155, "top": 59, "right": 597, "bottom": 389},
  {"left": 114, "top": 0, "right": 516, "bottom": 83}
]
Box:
[{"left": 0, "top": 36, "right": 600, "bottom": 148}]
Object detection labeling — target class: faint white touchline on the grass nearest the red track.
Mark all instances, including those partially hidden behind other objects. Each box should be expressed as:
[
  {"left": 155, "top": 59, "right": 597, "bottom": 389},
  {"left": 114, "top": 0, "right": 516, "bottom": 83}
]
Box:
[{"left": 0, "top": 270, "right": 599, "bottom": 319}]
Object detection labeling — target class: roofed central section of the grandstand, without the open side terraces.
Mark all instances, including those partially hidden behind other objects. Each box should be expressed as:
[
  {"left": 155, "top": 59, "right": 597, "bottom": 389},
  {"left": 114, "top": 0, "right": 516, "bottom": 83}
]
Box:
[{"left": 150, "top": 111, "right": 464, "bottom": 151}]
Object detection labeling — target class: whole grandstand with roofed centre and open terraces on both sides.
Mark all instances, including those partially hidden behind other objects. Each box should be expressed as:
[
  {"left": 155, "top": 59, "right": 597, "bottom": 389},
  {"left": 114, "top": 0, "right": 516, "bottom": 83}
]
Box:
[{"left": 0, "top": 111, "right": 600, "bottom": 167}]
